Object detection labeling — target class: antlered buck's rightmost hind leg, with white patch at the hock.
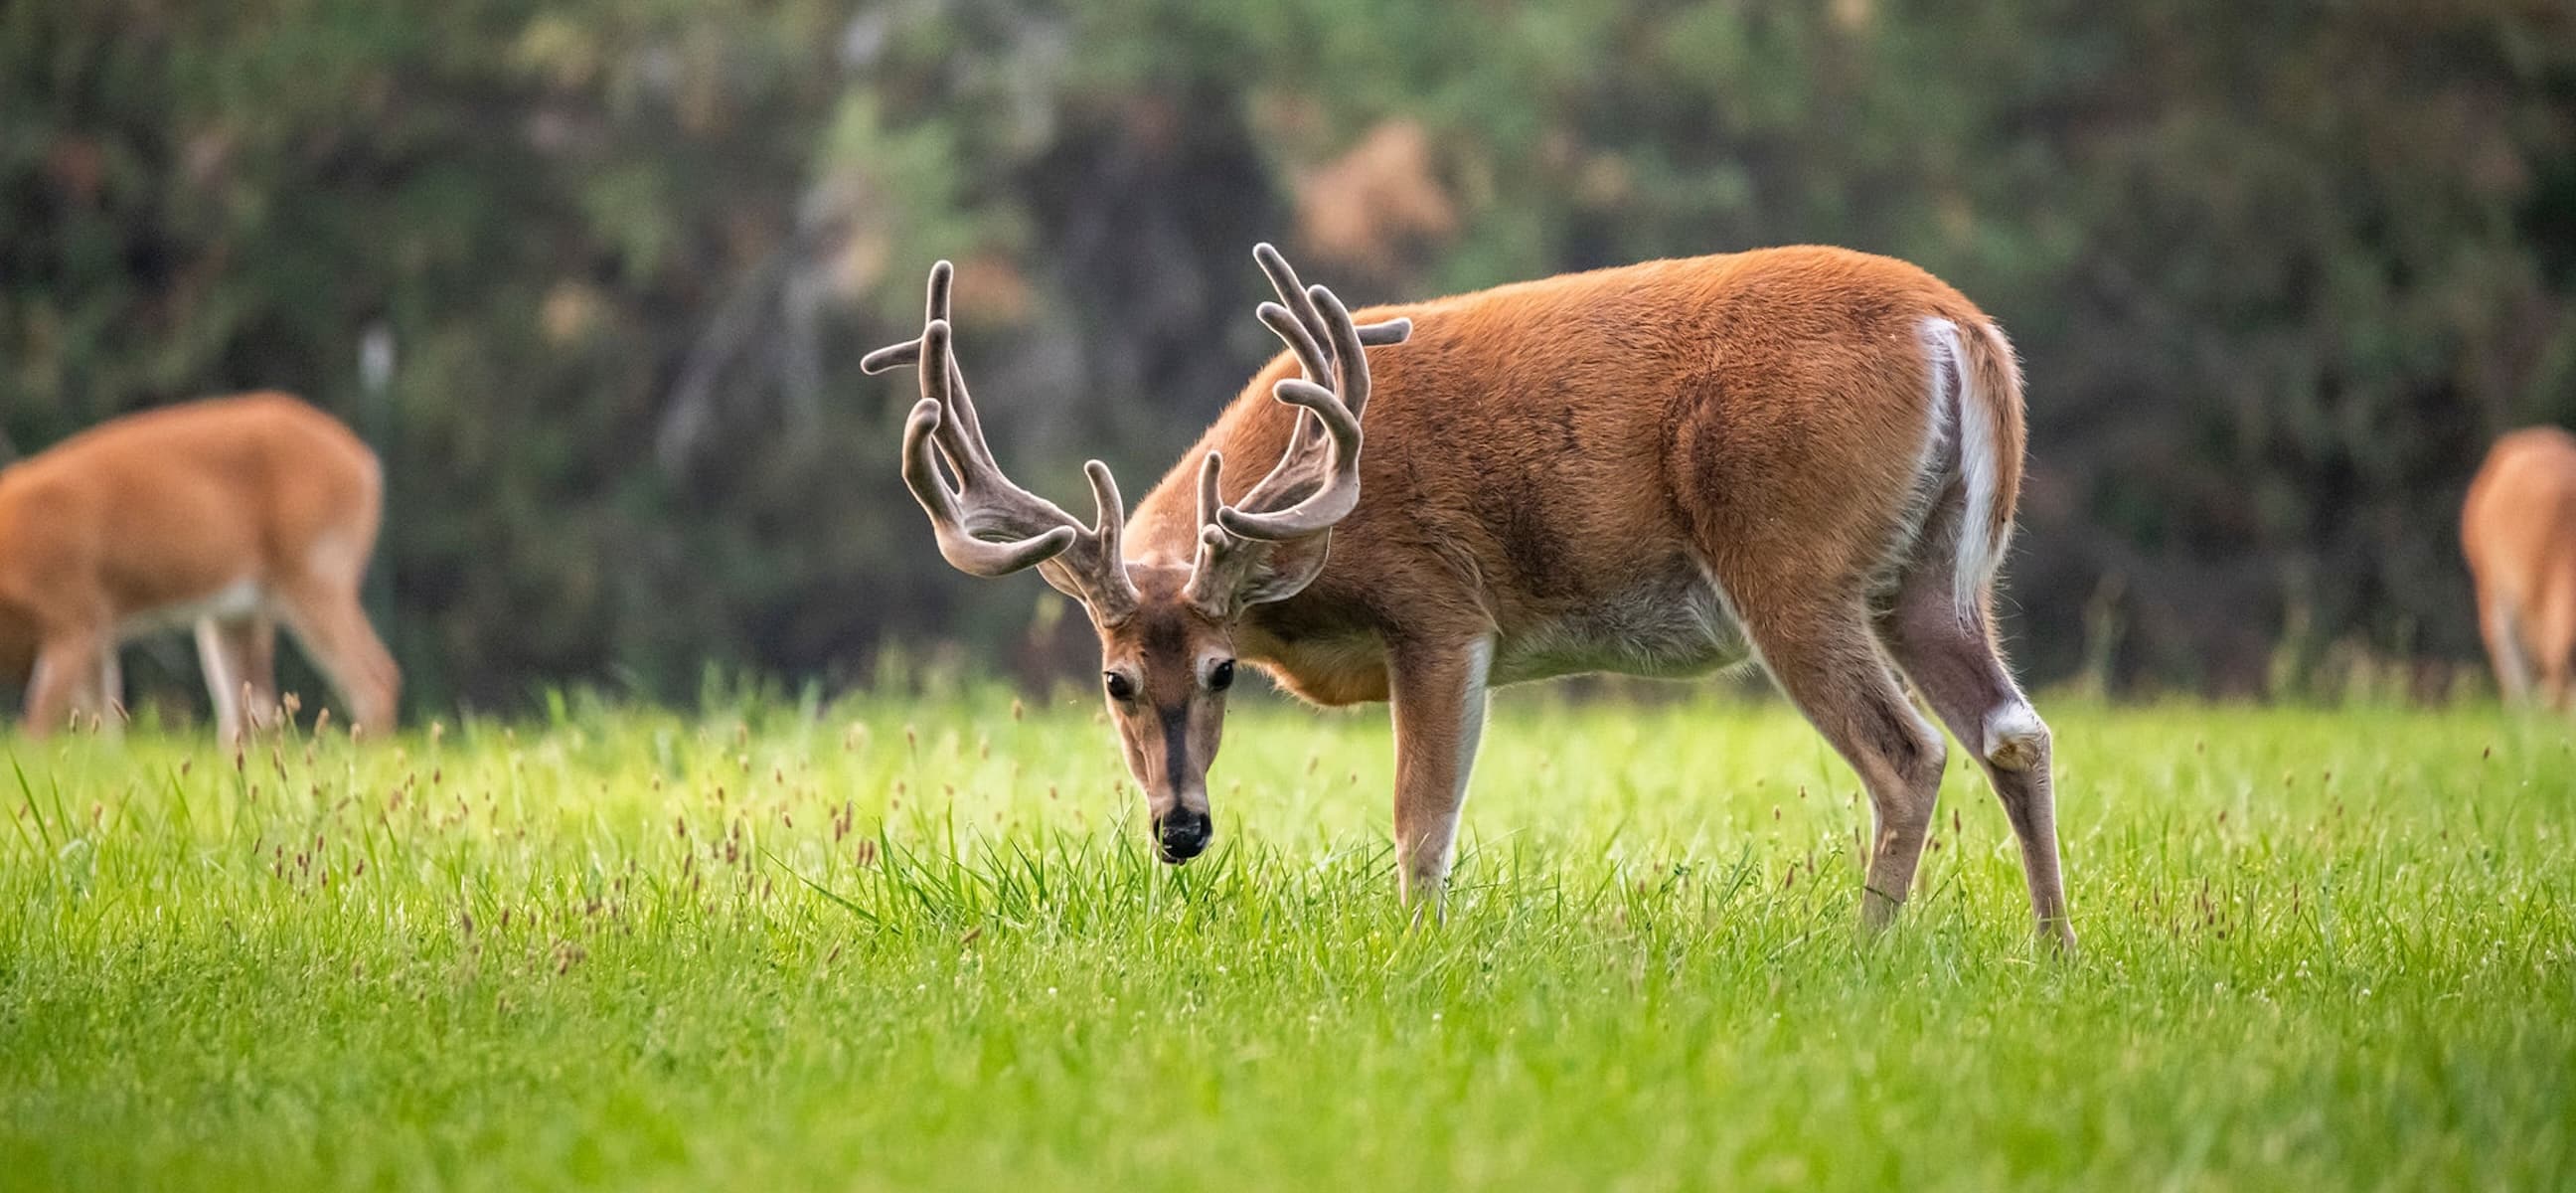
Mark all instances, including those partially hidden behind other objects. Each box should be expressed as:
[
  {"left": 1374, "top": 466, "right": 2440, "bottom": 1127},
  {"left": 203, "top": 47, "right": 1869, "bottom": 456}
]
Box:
[{"left": 1880, "top": 575, "right": 2076, "bottom": 948}]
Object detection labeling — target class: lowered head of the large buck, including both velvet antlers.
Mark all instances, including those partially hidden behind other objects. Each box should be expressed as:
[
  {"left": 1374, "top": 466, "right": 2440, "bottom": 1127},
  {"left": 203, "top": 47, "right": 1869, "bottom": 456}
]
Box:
[{"left": 861, "top": 245, "right": 1411, "bottom": 863}]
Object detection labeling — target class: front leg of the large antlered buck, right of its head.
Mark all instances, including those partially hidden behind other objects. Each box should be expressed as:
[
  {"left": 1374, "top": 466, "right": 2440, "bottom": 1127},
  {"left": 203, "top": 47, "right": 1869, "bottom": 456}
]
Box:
[{"left": 1385, "top": 636, "right": 1494, "bottom": 910}]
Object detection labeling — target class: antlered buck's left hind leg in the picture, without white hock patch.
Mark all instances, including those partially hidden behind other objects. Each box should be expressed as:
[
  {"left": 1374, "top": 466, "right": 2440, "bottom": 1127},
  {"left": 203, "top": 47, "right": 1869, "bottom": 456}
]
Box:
[{"left": 1744, "top": 605, "right": 1948, "bottom": 931}]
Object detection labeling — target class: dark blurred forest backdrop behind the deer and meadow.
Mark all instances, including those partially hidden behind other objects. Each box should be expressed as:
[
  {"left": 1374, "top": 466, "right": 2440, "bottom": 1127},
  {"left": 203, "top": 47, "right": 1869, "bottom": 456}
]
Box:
[{"left": 0, "top": 0, "right": 2576, "bottom": 706}]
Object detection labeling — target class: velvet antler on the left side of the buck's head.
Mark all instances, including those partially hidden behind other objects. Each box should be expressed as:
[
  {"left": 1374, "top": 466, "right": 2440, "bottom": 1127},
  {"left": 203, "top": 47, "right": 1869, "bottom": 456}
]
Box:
[{"left": 858, "top": 260, "right": 1136, "bottom": 621}]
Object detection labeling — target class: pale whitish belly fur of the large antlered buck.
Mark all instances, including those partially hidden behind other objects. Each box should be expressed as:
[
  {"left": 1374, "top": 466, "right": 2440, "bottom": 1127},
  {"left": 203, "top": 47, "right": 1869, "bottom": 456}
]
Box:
[{"left": 1494, "top": 565, "right": 1752, "bottom": 683}]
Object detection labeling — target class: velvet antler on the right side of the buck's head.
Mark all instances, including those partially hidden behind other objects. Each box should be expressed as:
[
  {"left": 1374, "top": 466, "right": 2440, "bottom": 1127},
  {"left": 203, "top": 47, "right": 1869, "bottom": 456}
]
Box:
[{"left": 1185, "top": 245, "right": 1414, "bottom": 610}]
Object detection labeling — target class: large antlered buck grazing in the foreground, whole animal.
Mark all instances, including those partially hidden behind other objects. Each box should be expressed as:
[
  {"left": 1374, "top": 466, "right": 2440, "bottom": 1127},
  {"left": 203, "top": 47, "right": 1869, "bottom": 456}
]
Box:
[{"left": 863, "top": 245, "right": 2074, "bottom": 945}]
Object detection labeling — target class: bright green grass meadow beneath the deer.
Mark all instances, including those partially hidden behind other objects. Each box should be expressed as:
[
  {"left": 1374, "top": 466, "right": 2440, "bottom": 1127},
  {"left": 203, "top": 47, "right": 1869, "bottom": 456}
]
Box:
[{"left": 0, "top": 693, "right": 2576, "bottom": 1190}]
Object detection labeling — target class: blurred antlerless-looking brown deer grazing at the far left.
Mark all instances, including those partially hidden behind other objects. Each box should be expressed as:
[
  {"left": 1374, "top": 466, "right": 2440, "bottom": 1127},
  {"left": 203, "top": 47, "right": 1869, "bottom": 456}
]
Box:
[{"left": 0, "top": 395, "right": 402, "bottom": 742}]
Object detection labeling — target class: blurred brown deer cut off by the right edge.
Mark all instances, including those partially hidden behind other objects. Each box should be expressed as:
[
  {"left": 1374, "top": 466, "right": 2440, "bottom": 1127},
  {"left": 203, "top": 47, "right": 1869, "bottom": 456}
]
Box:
[{"left": 2460, "top": 427, "right": 2576, "bottom": 709}]
